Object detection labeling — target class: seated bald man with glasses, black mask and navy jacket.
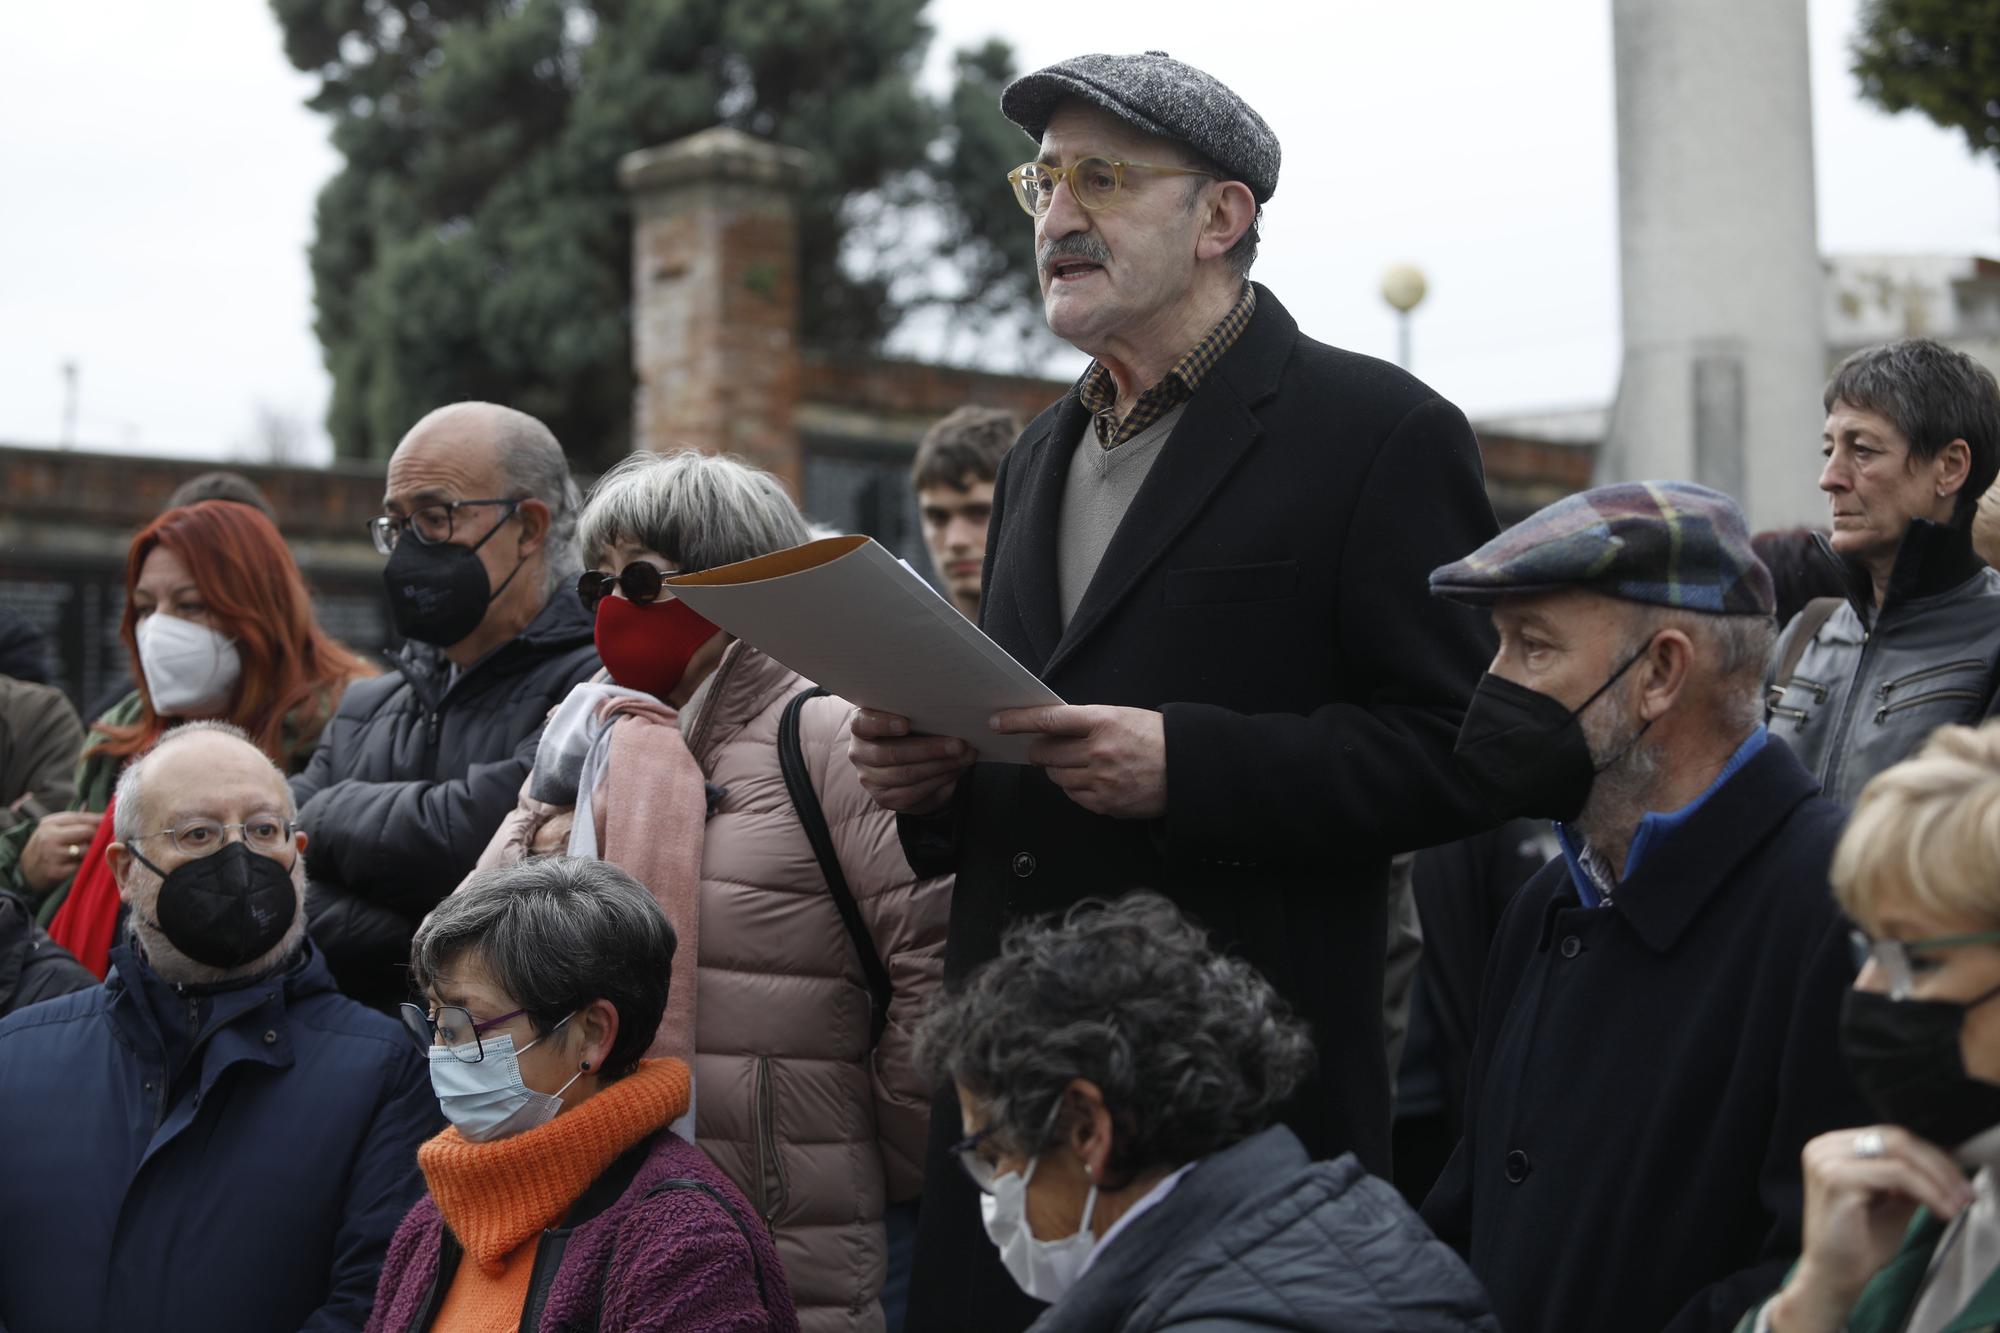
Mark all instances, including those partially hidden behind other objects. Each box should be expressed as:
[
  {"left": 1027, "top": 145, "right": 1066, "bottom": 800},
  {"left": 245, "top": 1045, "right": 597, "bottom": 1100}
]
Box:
[{"left": 0, "top": 723, "right": 440, "bottom": 1333}]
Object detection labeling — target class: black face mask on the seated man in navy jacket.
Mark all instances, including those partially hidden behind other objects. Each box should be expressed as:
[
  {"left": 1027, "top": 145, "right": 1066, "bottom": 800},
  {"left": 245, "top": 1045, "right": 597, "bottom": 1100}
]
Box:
[{"left": 132, "top": 843, "right": 298, "bottom": 967}]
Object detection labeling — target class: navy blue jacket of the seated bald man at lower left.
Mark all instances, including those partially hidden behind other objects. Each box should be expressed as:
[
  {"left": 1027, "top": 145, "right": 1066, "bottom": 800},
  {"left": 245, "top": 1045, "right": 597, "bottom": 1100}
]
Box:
[{"left": 0, "top": 943, "right": 442, "bottom": 1333}]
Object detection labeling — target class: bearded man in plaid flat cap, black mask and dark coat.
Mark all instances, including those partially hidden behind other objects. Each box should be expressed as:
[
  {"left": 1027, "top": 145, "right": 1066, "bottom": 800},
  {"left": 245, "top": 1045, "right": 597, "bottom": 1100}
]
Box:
[{"left": 1424, "top": 482, "right": 1866, "bottom": 1333}]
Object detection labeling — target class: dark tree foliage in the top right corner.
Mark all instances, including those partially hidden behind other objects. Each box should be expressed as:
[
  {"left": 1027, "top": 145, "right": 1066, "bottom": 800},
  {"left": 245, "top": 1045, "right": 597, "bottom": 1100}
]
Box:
[{"left": 1854, "top": 0, "right": 2000, "bottom": 162}]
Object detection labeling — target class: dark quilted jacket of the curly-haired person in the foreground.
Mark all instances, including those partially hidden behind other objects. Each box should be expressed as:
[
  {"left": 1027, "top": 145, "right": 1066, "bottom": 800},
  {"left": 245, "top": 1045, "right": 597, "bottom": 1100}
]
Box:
[{"left": 1032, "top": 1125, "right": 1500, "bottom": 1333}]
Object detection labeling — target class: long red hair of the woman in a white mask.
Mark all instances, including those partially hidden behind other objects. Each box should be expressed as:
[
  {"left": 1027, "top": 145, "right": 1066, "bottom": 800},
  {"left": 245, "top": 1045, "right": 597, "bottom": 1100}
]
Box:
[{"left": 96, "top": 500, "right": 376, "bottom": 767}]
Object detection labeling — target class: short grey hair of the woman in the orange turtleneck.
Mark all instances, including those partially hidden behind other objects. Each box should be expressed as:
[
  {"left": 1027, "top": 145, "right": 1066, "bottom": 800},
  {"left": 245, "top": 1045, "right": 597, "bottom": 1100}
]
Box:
[{"left": 410, "top": 857, "right": 694, "bottom": 1079}]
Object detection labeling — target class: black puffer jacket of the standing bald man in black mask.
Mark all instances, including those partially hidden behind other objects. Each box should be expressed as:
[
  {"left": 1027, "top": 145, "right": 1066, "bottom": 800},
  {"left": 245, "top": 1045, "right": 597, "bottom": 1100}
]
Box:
[{"left": 292, "top": 590, "right": 598, "bottom": 1009}]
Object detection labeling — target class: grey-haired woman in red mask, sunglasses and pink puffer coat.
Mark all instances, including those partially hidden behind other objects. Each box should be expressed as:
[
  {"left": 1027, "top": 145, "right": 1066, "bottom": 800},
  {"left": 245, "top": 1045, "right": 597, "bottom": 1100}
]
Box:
[{"left": 482, "top": 450, "right": 952, "bottom": 1333}]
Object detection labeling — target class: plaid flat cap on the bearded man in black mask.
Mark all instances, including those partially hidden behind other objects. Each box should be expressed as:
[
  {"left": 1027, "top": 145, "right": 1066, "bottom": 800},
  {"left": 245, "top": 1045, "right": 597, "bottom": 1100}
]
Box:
[{"left": 1430, "top": 482, "right": 1778, "bottom": 616}]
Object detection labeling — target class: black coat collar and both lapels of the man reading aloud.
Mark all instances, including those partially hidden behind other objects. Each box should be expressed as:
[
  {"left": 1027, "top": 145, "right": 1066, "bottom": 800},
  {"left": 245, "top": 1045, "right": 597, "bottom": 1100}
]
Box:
[{"left": 1008, "top": 284, "right": 1298, "bottom": 679}]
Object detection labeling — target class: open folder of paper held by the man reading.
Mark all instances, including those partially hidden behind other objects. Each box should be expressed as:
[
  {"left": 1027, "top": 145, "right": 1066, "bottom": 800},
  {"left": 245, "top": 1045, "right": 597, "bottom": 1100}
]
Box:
[{"left": 666, "top": 536, "right": 1062, "bottom": 765}]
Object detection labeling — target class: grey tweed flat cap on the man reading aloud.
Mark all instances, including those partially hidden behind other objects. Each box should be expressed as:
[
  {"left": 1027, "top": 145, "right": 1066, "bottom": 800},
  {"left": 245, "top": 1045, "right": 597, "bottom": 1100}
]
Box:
[{"left": 1000, "top": 50, "right": 1278, "bottom": 204}]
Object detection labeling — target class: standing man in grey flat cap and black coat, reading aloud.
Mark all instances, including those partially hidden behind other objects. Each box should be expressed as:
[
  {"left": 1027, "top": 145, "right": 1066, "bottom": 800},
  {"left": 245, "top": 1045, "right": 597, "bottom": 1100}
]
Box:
[{"left": 852, "top": 52, "right": 1494, "bottom": 1331}]
